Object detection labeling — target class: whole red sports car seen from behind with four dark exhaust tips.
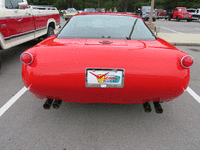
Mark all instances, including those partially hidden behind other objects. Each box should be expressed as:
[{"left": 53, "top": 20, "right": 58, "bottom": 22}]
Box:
[{"left": 21, "top": 13, "right": 193, "bottom": 113}]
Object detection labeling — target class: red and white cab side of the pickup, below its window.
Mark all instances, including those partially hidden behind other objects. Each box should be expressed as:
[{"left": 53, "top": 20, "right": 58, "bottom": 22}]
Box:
[{"left": 0, "top": 7, "right": 35, "bottom": 49}]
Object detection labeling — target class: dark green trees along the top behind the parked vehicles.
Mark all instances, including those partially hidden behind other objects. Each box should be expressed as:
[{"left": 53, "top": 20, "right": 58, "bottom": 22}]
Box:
[{"left": 28, "top": 0, "right": 200, "bottom": 12}]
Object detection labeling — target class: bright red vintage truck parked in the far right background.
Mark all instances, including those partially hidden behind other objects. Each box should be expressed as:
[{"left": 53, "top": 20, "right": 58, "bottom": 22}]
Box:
[{"left": 168, "top": 7, "right": 192, "bottom": 22}]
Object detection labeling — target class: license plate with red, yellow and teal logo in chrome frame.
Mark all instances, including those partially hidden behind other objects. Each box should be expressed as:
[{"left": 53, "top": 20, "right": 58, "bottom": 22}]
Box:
[{"left": 85, "top": 68, "right": 125, "bottom": 88}]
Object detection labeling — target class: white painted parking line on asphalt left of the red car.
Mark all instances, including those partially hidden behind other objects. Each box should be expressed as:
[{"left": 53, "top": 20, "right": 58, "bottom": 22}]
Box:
[{"left": 0, "top": 86, "right": 28, "bottom": 117}]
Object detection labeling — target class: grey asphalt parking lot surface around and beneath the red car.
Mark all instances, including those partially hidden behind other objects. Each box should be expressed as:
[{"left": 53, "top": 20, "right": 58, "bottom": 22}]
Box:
[{"left": 0, "top": 20, "right": 200, "bottom": 150}]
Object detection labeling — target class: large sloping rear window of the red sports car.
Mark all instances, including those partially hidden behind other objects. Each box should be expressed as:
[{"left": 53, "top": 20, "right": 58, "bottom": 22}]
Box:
[{"left": 57, "top": 15, "right": 155, "bottom": 40}]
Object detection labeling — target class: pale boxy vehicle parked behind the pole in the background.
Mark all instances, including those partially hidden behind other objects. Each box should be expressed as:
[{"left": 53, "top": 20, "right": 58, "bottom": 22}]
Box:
[{"left": 136, "top": 6, "right": 157, "bottom": 21}]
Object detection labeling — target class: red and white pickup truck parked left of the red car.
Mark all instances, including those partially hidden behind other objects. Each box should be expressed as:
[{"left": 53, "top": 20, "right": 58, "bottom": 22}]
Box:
[{"left": 0, "top": 0, "right": 60, "bottom": 49}]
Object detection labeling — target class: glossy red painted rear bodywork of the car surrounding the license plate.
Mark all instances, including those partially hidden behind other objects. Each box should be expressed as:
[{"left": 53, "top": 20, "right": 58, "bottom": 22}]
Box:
[{"left": 22, "top": 36, "right": 190, "bottom": 103}]
